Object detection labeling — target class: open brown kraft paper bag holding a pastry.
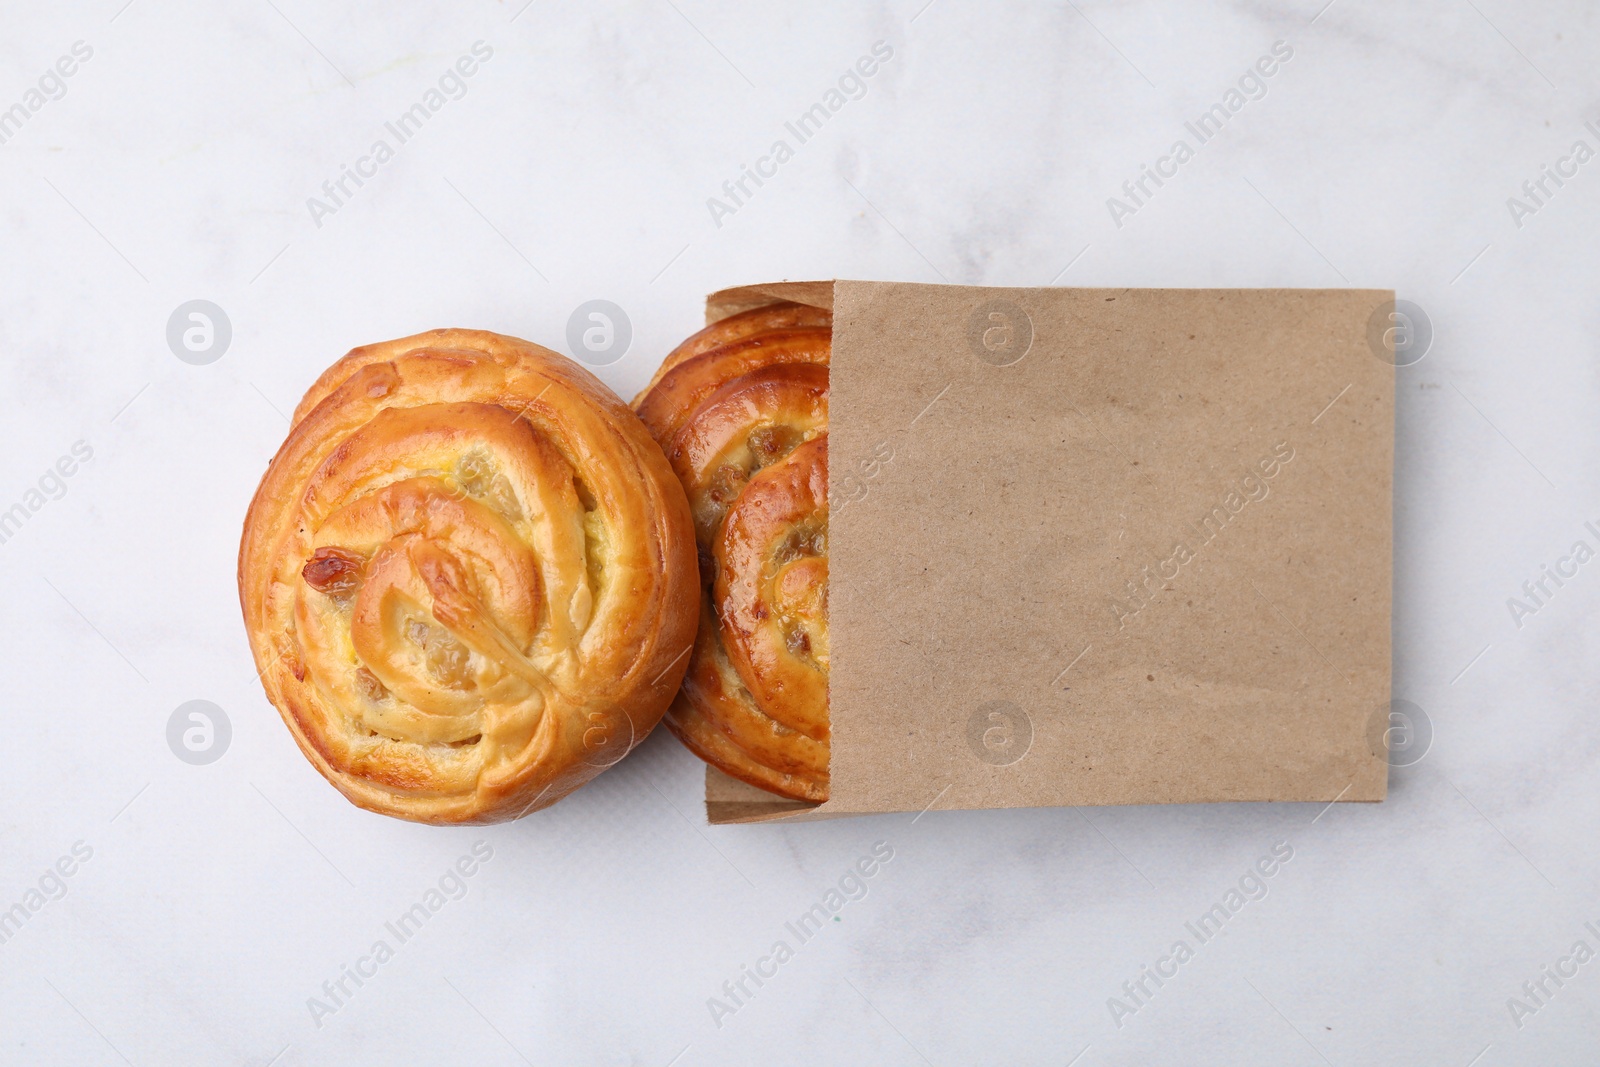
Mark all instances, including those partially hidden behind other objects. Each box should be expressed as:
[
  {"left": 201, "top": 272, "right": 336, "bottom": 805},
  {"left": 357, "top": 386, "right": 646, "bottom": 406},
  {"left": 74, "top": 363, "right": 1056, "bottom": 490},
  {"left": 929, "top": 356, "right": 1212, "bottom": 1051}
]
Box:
[{"left": 706, "top": 282, "right": 1394, "bottom": 824}]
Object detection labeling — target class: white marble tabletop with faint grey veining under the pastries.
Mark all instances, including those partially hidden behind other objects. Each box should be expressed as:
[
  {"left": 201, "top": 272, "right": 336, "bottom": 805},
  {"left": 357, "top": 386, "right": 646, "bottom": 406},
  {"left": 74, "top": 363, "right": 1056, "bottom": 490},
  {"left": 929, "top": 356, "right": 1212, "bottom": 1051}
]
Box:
[{"left": 0, "top": 0, "right": 1600, "bottom": 1067}]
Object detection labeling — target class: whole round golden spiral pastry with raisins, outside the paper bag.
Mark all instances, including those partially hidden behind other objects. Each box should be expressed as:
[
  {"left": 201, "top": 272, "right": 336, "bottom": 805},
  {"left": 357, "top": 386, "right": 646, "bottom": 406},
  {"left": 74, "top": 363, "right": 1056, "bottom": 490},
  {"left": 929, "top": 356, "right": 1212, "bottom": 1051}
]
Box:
[{"left": 238, "top": 330, "right": 696, "bottom": 824}]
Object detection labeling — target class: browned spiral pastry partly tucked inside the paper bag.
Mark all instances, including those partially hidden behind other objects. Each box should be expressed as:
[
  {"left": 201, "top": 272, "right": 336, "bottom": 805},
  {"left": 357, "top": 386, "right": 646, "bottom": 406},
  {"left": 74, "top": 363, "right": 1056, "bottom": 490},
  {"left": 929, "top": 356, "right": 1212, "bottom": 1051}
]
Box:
[{"left": 634, "top": 304, "right": 832, "bottom": 801}]
